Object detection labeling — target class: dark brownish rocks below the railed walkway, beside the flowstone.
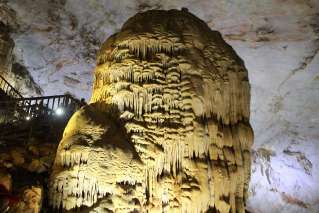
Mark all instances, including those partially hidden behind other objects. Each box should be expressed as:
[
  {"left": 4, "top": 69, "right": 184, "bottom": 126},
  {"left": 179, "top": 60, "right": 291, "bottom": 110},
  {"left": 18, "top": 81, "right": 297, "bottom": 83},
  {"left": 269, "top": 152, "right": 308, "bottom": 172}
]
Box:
[{"left": 0, "top": 136, "right": 58, "bottom": 213}]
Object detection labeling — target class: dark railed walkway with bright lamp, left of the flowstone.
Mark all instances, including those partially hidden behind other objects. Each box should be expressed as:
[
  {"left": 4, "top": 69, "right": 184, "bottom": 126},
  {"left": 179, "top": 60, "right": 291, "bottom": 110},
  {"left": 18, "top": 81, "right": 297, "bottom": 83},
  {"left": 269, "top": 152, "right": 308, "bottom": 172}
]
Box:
[{"left": 0, "top": 75, "right": 81, "bottom": 145}]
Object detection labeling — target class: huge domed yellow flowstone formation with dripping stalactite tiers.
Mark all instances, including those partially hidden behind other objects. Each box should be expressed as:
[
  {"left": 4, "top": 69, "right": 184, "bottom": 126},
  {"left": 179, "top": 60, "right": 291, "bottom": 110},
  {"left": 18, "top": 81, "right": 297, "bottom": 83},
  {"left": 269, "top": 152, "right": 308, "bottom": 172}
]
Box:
[{"left": 50, "top": 10, "right": 253, "bottom": 213}]
